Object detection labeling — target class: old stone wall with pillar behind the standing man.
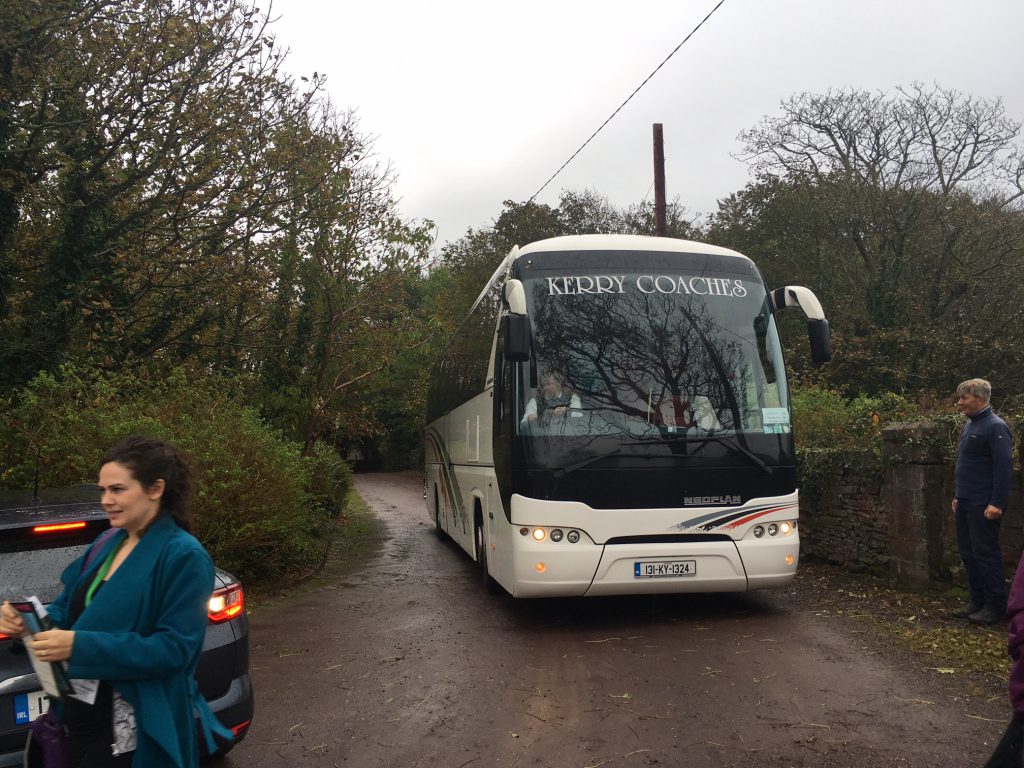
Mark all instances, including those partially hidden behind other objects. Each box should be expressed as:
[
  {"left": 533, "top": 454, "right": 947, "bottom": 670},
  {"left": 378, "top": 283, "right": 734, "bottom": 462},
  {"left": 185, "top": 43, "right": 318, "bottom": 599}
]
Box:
[{"left": 800, "top": 423, "right": 1024, "bottom": 585}]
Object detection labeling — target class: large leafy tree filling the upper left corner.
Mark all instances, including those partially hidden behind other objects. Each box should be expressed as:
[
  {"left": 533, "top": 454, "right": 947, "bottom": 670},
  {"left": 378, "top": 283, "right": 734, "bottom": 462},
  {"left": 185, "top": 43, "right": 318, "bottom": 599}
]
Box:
[{"left": 0, "top": 0, "right": 327, "bottom": 384}]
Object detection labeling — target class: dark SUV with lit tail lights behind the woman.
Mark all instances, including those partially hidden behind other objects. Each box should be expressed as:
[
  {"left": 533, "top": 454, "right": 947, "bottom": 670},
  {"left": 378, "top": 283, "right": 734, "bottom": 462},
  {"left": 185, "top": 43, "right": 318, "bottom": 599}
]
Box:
[{"left": 0, "top": 485, "right": 253, "bottom": 768}]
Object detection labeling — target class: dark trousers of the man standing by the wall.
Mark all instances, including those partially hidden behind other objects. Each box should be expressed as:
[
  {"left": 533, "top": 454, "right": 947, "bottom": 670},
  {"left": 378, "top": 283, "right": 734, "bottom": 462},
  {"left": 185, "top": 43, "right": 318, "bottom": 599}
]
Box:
[{"left": 955, "top": 499, "right": 1007, "bottom": 616}]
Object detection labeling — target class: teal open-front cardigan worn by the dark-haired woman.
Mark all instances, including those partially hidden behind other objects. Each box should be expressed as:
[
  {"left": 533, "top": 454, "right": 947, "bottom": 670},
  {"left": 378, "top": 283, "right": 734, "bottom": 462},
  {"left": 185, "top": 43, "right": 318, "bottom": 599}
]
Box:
[{"left": 48, "top": 514, "right": 231, "bottom": 768}]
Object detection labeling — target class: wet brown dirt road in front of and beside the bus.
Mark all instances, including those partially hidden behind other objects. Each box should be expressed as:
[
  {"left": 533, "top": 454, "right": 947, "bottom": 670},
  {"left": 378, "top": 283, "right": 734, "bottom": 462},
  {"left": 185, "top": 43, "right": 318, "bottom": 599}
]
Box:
[{"left": 220, "top": 475, "right": 1008, "bottom": 768}]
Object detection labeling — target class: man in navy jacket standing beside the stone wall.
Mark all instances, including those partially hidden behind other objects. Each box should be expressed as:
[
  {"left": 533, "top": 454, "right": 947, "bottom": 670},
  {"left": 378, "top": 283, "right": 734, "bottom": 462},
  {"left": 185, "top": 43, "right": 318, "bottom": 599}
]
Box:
[{"left": 952, "top": 379, "right": 1014, "bottom": 624}]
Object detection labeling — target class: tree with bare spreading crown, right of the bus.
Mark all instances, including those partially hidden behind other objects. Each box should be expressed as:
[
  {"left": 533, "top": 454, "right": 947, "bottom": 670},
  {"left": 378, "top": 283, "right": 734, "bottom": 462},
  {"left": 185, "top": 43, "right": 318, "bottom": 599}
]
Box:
[{"left": 714, "top": 84, "right": 1024, "bottom": 389}]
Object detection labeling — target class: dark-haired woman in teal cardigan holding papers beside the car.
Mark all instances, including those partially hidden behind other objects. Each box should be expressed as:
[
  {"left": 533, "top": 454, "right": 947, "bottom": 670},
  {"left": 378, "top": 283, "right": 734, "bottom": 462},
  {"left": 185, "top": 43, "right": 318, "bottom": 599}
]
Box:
[{"left": 0, "top": 436, "right": 230, "bottom": 768}]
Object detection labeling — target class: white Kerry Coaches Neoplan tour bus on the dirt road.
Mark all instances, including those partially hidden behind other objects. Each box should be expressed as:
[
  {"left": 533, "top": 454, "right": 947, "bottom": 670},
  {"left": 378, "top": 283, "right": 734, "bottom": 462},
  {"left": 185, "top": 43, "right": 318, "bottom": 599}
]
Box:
[{"left": 425, "top": 234, "right": 831, "bottom": 597}]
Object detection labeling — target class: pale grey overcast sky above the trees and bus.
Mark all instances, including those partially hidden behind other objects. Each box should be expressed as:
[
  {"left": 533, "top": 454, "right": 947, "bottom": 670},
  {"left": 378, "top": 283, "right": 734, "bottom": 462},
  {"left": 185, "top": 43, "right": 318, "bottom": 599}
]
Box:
[{"left": 261, "top": 0, "right": 1024, "bottom": 252}]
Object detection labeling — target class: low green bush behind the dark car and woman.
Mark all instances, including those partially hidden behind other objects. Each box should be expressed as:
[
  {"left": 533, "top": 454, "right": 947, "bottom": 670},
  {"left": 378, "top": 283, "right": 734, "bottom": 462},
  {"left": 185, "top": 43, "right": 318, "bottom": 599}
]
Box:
[{"left": 0, "top": 367, "right": 351, "bottom": 585}]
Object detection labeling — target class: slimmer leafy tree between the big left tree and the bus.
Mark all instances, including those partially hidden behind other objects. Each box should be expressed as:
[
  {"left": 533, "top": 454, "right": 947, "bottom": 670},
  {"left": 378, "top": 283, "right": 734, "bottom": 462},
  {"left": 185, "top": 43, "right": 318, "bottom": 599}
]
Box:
[{"left": 251, "top": 113, "right": 431, "bottom": 450}]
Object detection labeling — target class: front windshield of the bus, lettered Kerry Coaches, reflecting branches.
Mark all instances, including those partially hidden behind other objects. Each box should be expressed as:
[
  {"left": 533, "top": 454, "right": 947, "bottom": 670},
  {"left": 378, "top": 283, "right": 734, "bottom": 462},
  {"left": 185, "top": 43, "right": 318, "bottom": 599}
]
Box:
[{"left": 514, "top": 264, "right": 791, "bottom": 450}]
